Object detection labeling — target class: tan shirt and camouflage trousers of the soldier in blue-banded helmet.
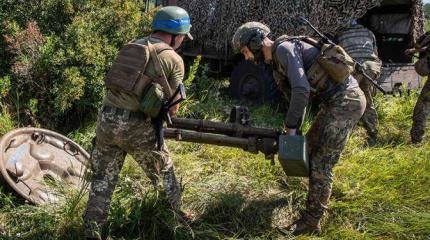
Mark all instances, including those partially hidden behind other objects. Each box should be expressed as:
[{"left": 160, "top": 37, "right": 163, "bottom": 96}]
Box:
[{"left": 84, "top": 38, "right": 184, "bottom": 237}]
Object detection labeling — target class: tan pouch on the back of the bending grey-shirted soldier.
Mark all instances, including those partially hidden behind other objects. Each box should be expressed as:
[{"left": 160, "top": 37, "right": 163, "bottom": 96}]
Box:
[{"left": 311, "top": 44, "right": 355, "bottom": 83}]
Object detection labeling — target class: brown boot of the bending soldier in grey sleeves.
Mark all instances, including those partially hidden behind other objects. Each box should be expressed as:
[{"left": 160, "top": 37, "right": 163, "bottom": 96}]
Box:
[{"left": 285, "top": 212, "right": 321, "bottom": 235}]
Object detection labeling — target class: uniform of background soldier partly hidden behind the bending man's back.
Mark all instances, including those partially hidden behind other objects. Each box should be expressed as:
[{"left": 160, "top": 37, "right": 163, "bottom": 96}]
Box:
[{"left": 337, "top": 24, "right": 382, "bottom": 145}]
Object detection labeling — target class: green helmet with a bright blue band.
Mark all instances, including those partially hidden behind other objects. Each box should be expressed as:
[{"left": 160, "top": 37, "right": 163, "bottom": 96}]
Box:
[{"left": 152, "top": 6, "right": 193, "bottom": 40}]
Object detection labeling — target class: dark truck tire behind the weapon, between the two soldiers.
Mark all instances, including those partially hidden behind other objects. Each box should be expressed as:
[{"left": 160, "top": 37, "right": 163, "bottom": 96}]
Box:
[{"left": 230, "top": 60, "right": 281, "bottom": 105}]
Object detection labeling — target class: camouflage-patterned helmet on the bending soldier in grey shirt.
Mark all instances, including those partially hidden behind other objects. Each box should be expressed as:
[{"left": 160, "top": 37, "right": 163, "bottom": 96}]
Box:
[{"left": 231, "top": 22, "right": 270, "bottom": 52}]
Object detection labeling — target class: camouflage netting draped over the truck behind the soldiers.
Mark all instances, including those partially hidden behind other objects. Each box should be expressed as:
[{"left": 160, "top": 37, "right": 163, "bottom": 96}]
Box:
[{"left": 178, "top": 0, "right": 422, "bottom": 54}]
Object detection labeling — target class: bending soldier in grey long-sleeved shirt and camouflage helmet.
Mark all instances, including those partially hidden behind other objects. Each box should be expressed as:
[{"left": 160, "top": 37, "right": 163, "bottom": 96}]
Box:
[{"left": 232, "top": 22, "right": 366, "bottom": 235}]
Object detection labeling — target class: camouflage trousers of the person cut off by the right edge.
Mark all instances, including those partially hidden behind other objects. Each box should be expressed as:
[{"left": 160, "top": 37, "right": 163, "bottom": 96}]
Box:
[{"left": 411, "top": 78, "right": 430, "bottom": 143}]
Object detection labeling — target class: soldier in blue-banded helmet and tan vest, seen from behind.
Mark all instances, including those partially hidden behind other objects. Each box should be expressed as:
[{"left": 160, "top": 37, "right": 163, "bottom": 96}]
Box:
[{"left": 84, "top": 6, "right": 192, "bottom": 239}]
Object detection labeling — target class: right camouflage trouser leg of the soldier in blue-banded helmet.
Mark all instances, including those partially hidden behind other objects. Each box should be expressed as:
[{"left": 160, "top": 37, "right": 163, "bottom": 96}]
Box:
[{"left": 127, "top": 120, "right": 182, "bottom": 210}]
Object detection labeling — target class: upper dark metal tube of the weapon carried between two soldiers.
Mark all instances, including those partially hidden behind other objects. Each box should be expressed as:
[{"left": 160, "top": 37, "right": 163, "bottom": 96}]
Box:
[{"left": 169, "top": 118, "right": 281, "bottom": 139}]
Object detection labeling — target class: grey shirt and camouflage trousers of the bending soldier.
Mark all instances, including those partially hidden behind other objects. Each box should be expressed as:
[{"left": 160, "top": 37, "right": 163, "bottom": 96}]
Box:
[{"left": 273, "top": 38, "right": 366, "bottom": 234}]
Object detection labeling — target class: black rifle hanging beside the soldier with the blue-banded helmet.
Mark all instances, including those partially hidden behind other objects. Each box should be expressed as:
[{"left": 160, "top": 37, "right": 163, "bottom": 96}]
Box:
[{"left": 154, "top": 83, "right": 186, "bottom": 151}]
